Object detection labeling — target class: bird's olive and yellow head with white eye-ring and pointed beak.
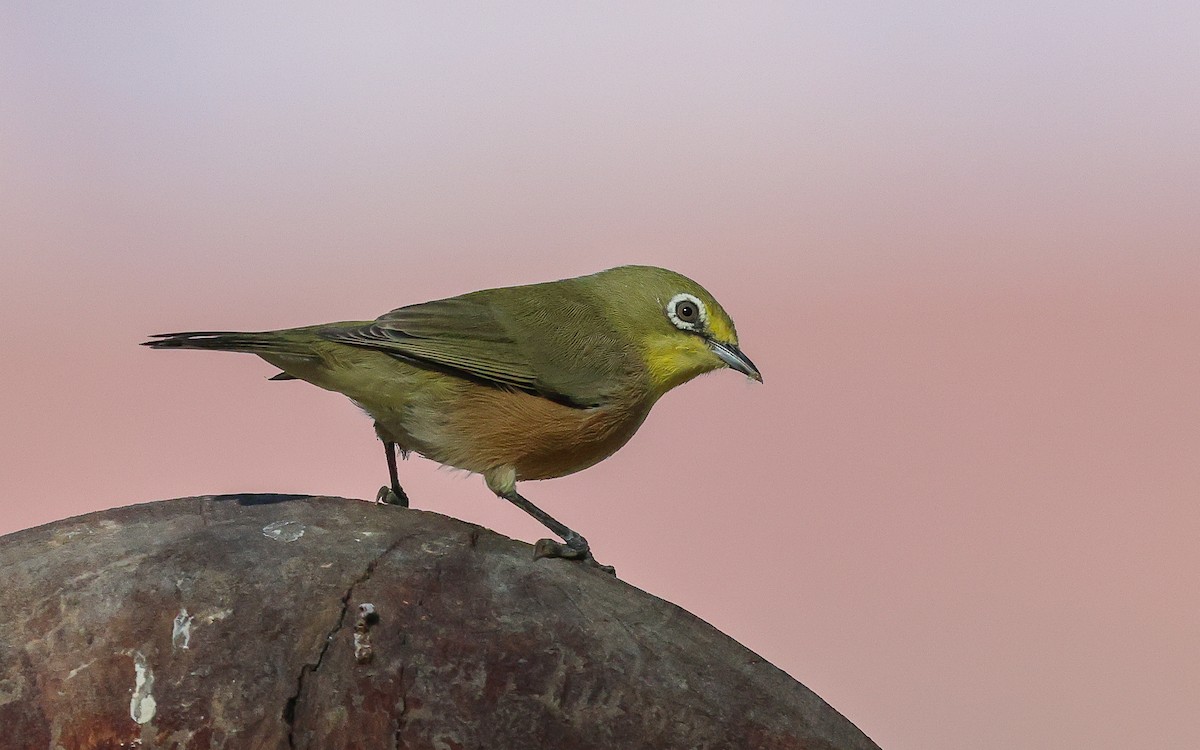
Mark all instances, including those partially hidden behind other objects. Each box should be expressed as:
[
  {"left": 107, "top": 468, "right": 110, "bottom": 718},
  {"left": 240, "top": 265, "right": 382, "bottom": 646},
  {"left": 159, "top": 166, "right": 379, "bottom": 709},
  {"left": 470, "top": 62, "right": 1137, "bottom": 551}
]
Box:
[{"left": 592, "top": 265, "right": 762, "bottom": 396}]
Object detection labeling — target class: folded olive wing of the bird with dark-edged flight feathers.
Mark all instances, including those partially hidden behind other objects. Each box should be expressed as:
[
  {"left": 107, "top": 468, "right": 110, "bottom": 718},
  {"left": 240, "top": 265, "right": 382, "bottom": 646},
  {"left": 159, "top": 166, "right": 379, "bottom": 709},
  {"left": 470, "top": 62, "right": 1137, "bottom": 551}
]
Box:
[{"left": 322, "top": 295, "right": 584, "bottom": 406}]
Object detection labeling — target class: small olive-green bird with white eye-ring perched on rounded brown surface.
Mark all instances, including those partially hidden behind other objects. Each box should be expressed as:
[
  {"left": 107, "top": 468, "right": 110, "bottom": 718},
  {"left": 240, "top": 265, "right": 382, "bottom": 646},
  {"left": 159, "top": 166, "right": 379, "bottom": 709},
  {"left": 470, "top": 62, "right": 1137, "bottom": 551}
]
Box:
[{"left": 143, "top": 265, "right": 762, "bottom": 571}]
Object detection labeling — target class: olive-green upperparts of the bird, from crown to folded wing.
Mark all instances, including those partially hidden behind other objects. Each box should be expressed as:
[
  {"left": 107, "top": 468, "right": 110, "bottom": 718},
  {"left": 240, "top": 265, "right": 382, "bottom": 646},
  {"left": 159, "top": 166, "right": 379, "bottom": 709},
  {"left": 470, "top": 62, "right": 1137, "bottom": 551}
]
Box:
[{"left": 322, "top": 266, "right": 724, "bottom": 407}]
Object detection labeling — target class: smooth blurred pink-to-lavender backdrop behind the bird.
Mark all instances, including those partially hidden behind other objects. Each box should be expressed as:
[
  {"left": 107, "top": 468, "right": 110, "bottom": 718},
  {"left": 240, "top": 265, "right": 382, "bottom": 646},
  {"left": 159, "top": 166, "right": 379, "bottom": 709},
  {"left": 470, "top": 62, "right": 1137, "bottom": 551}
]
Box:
[{"left": 0, "top": 1, "right": 1200, "bottom": 750}]
